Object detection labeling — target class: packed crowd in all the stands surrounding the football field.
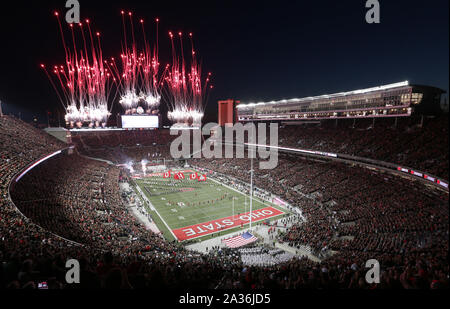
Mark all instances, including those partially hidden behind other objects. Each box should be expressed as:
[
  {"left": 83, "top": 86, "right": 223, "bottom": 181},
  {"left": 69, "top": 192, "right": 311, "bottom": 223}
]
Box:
[{"left": 0, "top": 116, "right": 449, "bottom": 289}]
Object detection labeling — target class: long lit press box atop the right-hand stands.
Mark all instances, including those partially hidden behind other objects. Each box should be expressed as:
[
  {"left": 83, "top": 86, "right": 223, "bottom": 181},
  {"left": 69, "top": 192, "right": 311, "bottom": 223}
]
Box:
[{"left": 236, "top": 81, "right": 444, "bottom": 122}]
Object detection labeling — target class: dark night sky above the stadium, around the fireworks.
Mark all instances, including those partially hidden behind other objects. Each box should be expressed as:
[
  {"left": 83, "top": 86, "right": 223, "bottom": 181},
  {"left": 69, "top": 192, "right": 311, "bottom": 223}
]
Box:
[{"left": 0, "top": 0, "right": 449, "bottom": 122}]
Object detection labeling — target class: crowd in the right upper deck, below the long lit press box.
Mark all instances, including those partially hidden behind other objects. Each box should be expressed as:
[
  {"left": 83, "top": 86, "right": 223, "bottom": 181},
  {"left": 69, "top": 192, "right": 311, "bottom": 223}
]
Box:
[{"left": 279, "top": 115, "right": 449, "bottom": 179}]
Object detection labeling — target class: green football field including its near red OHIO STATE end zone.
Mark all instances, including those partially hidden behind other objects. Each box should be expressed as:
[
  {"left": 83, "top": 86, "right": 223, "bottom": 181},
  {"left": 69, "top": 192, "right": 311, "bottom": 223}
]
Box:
[{"left": 135, "top": 171, "right": 286, "bottom": 241}]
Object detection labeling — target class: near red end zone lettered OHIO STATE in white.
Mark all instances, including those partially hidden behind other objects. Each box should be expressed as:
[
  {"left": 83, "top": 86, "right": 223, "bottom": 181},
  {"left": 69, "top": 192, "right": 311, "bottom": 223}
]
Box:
[{"left": 172, "top": 207, "right": 284, "bottom": 241}]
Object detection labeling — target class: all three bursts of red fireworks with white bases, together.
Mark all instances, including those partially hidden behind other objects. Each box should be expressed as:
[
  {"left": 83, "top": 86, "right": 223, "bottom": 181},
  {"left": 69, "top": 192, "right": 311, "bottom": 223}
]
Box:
[{"left": 41, "top": 11, "right": 212, "bottom": 128}]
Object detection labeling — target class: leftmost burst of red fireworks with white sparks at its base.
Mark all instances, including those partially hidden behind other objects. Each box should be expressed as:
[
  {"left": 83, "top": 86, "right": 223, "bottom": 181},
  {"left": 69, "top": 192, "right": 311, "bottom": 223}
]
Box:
[{"left": 41, "top": 12, "right": 116, "bottom": 127}]
